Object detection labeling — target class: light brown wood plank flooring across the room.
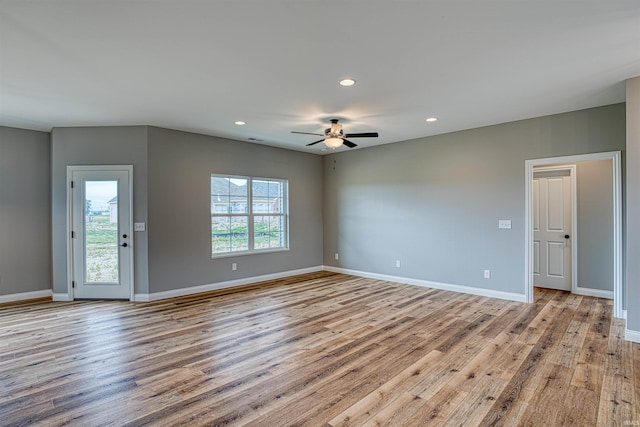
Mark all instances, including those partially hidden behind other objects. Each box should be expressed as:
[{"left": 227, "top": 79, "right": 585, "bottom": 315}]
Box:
[{"left": 0, "top": 272, "right": 640, "bottom": 427}]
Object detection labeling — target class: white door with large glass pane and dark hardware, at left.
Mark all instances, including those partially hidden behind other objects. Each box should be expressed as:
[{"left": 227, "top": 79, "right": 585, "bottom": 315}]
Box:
[{"left": 70, "top": 166, "right": 133, "bottom": 299}]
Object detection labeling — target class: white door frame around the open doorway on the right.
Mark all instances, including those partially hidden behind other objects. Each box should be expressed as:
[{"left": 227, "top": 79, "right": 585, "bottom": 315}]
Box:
[{"left": 524, "top": 151, "right": 624, "bottom": 318}]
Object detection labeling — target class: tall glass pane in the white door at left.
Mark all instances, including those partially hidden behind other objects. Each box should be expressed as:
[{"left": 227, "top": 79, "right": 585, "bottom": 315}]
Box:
[{"left": 84, "top": 181, "right": 119, "bottom": 283}]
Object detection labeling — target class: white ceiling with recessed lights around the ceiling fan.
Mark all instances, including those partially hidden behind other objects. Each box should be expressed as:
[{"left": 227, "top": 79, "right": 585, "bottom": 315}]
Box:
[{"left": 0, "top": 0, "right": 640, "bottom": 153}]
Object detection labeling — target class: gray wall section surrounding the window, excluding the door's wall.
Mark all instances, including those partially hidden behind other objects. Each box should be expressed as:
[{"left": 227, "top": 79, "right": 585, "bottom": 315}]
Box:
[{"left": 148, "top": 127, "right": 322, "bottom": 292}]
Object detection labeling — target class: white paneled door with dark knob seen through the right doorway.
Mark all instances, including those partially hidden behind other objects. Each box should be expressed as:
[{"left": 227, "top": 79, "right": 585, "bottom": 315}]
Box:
[{"left": 533, "top": 171, "right": 573, "bottom": 291}]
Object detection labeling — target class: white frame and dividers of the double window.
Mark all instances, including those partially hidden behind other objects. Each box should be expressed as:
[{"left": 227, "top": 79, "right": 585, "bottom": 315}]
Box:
[{"left": 209, "top": 173, "right": 289, "bottom": 259}]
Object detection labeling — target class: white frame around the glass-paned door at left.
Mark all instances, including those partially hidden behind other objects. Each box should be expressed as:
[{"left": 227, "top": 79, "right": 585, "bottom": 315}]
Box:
[{"left": 66, "top": 165, "right": 135, "bottom": 301}]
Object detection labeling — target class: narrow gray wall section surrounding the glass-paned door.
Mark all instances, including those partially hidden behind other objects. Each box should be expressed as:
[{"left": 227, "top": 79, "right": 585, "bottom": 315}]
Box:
[{"left": 51, "top": 126, "right": 149, "bottom": 293}]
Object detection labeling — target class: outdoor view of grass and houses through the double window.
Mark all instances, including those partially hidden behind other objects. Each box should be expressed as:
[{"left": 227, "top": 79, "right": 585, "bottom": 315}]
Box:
[{"left": 211, "top": 174, "right": 289, "bottom": 257}]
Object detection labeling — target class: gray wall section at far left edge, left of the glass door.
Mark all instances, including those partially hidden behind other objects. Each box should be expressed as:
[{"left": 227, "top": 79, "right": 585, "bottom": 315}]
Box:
[{"left": 0, "top": 127, "right": 51, "bottom": 295}]
